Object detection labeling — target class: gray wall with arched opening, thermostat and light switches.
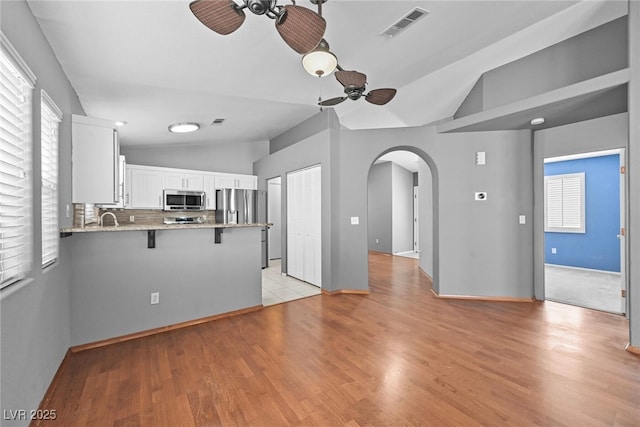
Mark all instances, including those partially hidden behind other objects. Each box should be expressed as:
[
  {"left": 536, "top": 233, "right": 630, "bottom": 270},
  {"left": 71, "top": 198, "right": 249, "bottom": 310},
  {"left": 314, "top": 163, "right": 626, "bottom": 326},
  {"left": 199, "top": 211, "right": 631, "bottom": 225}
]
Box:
[{"left": 337, "top": 127, "right": 533, "bottom": 298}]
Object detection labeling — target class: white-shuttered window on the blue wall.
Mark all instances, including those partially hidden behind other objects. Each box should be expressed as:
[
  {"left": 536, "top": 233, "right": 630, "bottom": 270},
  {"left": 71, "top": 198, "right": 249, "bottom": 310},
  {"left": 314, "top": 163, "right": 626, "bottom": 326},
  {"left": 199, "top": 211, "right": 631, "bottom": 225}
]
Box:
[{"left": 544, "top": 173, "right": 585, "bottom": 233}]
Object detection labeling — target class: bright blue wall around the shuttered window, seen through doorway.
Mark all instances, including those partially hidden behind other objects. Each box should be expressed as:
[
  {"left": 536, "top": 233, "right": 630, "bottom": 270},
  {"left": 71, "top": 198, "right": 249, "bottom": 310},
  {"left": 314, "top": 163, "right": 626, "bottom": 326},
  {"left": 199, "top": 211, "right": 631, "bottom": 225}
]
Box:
[{"left": 544, "top": 154, "right": 620, "bottom": 272}]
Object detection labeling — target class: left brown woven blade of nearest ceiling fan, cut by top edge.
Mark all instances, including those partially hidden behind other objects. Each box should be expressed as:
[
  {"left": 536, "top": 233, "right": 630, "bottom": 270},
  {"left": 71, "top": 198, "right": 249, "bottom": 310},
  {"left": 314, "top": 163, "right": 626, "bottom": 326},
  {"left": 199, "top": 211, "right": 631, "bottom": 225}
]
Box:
[{"left": 189, "top": 0, "right": 245, "bottom": 35}]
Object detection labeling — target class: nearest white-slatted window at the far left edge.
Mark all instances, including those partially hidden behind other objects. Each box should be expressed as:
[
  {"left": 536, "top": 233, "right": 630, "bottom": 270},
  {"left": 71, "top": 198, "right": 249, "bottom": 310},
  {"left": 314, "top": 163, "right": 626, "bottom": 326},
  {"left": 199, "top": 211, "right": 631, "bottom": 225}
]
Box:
[{"left": 0, "top": 33, "right": 35, "bottom": 288}]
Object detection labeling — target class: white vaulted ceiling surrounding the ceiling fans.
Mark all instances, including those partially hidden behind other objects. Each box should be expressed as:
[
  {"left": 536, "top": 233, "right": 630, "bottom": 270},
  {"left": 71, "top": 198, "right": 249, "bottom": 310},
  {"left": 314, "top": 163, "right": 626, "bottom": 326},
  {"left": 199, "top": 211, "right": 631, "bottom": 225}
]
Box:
[{"left": 28, "top": 0, "right": 626, "bottom": 146}]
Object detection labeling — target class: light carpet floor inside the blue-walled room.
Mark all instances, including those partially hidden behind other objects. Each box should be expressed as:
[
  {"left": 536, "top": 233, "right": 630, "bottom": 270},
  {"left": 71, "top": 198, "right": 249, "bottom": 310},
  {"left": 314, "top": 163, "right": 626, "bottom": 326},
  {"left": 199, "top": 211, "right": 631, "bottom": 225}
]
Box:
[{"left": 545, "top": 264, "right": 623, "bottom": 313}]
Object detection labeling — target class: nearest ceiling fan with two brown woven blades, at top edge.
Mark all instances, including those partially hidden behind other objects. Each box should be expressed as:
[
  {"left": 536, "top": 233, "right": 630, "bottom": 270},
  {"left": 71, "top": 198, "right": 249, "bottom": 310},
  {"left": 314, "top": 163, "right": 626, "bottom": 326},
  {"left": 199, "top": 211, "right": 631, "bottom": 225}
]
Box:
[{"left": 189, "top": 0, "right": 327, "bottom": 54}]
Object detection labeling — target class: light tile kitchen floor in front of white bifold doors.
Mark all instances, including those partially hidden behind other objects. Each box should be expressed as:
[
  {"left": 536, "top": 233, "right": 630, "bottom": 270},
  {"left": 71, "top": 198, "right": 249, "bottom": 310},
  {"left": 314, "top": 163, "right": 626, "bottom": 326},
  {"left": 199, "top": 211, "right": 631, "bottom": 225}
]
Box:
[{"left": 262, "top": 259, "right": 322, "bottom": 307}]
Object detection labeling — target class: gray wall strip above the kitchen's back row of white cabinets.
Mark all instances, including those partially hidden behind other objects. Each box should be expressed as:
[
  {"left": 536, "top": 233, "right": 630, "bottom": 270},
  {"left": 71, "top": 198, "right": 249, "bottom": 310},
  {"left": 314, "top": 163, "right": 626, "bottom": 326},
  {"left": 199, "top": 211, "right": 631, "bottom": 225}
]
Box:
[{"left": 121, "top": 141, "right": 269, "bottom": 174}]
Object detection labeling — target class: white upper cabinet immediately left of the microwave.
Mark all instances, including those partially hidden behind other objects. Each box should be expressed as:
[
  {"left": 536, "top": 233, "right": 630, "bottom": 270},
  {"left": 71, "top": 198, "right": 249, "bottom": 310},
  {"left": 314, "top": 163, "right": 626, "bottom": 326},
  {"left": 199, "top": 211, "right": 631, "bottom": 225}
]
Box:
[{"left": 125, "top": 165, "right": 164, "bottom": 209}]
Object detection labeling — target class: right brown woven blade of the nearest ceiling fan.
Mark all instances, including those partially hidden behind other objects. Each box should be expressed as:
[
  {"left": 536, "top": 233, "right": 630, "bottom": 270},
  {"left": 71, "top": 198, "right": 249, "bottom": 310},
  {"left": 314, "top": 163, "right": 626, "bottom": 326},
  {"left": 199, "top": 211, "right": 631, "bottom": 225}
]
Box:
[{"left": 276, "top": 5, "right": 327, "bottom": 54}]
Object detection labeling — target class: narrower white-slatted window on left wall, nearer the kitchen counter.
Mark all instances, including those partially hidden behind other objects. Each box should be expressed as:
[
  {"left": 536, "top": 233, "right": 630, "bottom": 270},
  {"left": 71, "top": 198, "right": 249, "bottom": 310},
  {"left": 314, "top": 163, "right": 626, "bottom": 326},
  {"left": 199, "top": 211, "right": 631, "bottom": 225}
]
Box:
[{"left": 40, "top": 91, "right": 62, "bottom": 268}]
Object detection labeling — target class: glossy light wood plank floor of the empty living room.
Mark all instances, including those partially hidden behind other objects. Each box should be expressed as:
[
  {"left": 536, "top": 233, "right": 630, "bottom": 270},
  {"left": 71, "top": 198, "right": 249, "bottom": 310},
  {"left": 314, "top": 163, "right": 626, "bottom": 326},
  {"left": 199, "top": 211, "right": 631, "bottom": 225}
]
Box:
[{"left": 36, "top": 254, "right": 640, "bottom": 427}]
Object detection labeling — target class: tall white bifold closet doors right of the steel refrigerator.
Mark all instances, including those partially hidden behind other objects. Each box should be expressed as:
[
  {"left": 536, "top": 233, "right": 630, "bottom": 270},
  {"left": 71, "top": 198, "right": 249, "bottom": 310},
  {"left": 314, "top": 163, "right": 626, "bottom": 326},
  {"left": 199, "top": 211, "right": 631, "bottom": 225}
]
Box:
[{"left": 287, "top": 166, "right": 322, "bottom": 286}]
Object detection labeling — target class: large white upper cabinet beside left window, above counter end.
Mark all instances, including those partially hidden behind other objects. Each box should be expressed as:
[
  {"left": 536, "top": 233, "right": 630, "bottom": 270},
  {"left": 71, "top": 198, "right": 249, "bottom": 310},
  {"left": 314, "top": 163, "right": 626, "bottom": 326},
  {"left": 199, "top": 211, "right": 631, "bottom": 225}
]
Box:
[{"left": 71, "top": 115, "right": 120, "bottom": 204}]
